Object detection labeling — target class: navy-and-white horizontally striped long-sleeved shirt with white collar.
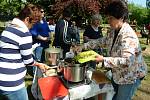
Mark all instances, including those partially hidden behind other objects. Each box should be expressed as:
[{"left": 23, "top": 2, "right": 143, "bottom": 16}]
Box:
[{"left": 0, "top": 18, "right": 34, "bottom": 91}]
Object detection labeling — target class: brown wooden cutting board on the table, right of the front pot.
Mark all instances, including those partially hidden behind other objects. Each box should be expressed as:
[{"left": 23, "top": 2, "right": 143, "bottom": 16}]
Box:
[{"left": 92, "top": 71, "right": 111, "bottom": 84}]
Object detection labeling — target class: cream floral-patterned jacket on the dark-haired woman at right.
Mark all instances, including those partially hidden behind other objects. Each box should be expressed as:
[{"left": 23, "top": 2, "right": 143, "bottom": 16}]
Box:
[{"left": 83, "top": 23, "right": 147, "bottom": 84}]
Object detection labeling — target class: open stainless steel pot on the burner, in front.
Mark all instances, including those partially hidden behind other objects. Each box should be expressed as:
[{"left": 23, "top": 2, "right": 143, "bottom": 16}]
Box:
[{"left": 63, "top": 64, "right": 85, "bottom": 82}]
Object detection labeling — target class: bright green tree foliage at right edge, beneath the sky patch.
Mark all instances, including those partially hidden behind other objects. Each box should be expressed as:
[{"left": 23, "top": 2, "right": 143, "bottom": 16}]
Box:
[{"left": 128, "top": 4, "right": 150, "bottom": 26}]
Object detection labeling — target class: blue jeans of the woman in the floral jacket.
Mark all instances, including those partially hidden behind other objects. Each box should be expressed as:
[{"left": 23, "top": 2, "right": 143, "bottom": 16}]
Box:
[{"left": 112, "top": 79, "right": 141, "bottom": 100}]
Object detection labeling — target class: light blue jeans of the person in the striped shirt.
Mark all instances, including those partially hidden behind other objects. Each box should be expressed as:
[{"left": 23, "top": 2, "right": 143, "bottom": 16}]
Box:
[{"left": 0, "top": 87, "right": 28, "bottom": 100}]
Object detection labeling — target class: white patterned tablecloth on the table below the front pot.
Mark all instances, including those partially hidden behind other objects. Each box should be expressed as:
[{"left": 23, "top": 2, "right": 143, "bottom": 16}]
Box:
[{"left": 69, "top": 81, "right": 114, "bottom": 100}]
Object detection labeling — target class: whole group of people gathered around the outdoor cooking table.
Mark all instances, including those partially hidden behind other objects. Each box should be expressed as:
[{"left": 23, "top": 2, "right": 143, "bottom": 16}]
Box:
[{"left": 0, "top": 0, "right": 147, "bottom": 100}]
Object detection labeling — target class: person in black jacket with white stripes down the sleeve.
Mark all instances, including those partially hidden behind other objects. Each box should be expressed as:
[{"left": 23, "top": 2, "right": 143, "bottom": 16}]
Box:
[{"left": 53, "top": 8, "right": 72, "bottom": 57}]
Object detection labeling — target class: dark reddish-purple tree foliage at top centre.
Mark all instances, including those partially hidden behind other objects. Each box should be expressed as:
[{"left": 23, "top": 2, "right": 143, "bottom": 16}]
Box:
[{"left": 50, "top": 0, "right": 111, "bottom": 26}]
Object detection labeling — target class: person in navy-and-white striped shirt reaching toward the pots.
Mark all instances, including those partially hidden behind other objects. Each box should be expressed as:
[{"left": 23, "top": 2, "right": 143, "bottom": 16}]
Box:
[{"left": 0, "top": 4, "right": 47, "bottom": 100}]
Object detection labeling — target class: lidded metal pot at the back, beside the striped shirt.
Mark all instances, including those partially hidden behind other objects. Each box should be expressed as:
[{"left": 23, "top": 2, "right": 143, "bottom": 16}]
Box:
[{"left": 45, "top": 48, "right": 62, "bottom": 66}]
